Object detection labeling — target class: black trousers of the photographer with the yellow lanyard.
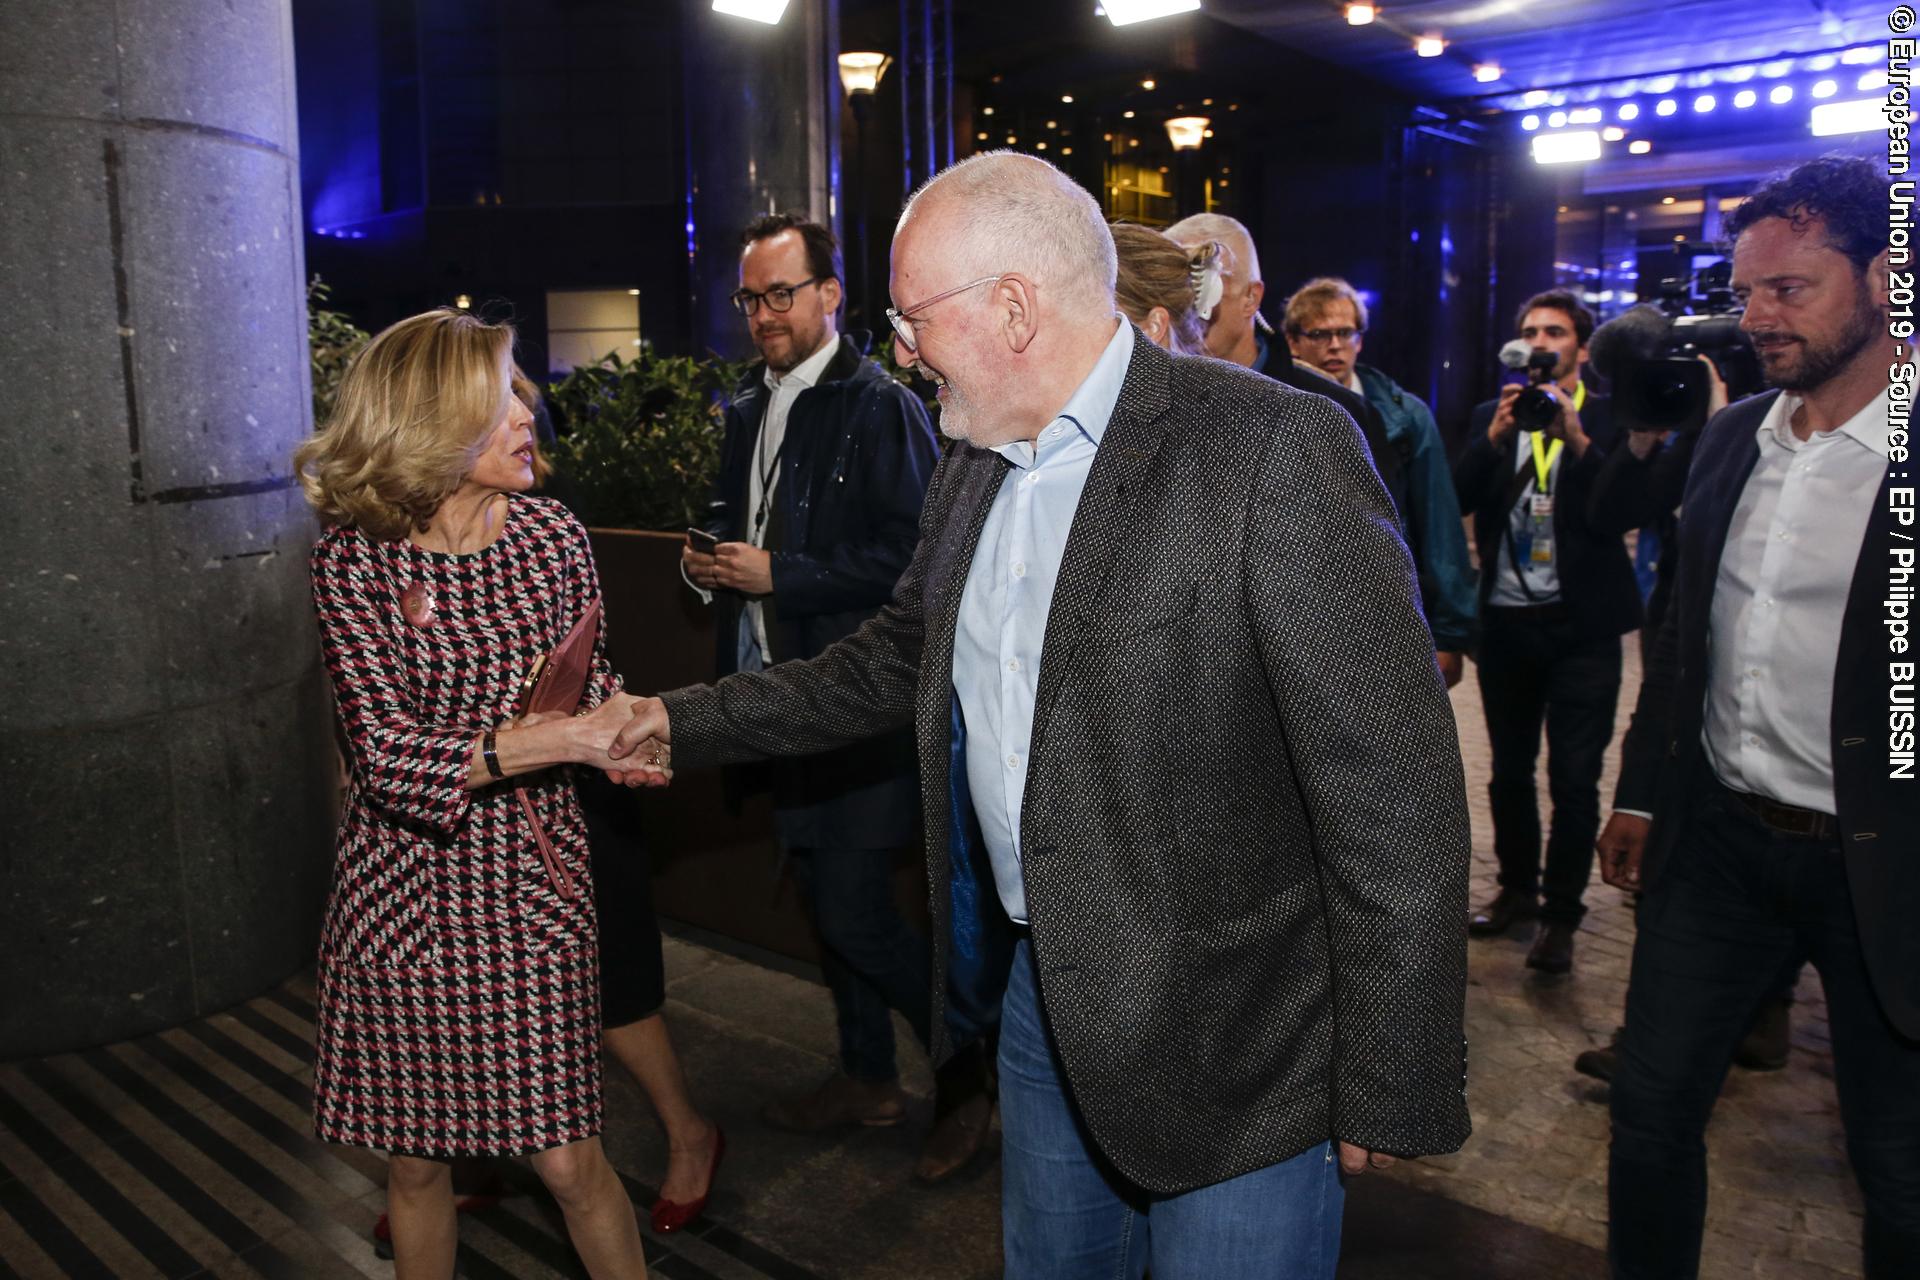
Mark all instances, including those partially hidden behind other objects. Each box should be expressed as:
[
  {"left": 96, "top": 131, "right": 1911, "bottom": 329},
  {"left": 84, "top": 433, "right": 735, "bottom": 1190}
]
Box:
[{"left": 1478, "top": 604, "right": 1620, "bottom": 925}]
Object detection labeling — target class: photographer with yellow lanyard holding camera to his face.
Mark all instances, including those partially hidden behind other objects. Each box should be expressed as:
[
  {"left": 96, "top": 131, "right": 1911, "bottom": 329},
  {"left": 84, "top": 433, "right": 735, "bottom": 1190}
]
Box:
[{"left": 1453, "top": 292, "right": 1640, "bottom": 973}]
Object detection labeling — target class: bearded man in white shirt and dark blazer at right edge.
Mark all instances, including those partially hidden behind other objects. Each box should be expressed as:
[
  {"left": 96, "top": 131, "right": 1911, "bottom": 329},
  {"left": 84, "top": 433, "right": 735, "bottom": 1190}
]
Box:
[{"left": 1599, "top": 155, "right": 1920, "bottom": 1276}]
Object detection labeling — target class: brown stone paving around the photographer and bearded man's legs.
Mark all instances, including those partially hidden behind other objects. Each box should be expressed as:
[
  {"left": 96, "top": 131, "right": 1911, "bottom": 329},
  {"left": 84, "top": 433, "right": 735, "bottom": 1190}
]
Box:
[{"left": 1436, "top": 652, "right": 1860, "bottom": 1280}]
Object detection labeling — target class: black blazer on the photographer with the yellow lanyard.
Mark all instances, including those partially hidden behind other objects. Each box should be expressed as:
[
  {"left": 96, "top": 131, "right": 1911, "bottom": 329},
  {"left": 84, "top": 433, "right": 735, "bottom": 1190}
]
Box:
[{"left": 1453, "top": 391, "right": 1640, "bottom": 635}]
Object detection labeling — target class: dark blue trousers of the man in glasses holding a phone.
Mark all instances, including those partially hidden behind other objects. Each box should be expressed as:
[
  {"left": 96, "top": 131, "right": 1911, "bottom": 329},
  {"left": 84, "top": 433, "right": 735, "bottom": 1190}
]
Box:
[{"left": 787, "top": 848, "right": 933, "bottom": 1080}]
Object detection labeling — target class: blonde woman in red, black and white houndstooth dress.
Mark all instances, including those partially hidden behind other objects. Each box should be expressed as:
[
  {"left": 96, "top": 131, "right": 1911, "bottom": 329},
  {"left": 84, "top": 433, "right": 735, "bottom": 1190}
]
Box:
[{"left": 298, "top": 311, "right": 659, "bottom": 1276}]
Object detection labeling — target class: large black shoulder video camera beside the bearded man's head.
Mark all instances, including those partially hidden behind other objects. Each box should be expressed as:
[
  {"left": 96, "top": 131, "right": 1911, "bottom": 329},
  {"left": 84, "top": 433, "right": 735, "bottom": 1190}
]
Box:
[{"left": 1588, "top": 261, "right": 1761, "bottom": 432}]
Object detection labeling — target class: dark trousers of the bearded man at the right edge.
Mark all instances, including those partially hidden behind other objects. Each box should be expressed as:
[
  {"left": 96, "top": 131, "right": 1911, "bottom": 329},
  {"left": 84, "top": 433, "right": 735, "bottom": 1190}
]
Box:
[{"left": 1607, "top": 787, "right": 1920, "bottom": 1280}]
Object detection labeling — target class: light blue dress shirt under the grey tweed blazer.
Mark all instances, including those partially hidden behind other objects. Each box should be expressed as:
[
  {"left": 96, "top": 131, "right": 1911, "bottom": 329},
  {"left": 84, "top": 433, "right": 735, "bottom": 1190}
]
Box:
[{"left": 954, "top": 320, "right": 1133, "bottom": 921}]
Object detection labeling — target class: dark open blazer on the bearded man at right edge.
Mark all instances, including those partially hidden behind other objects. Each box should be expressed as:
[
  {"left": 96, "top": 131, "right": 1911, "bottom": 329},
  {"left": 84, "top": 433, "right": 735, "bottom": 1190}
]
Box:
[{"left": 1613, "top": 391, "right": 1920, "bottom": 1038}]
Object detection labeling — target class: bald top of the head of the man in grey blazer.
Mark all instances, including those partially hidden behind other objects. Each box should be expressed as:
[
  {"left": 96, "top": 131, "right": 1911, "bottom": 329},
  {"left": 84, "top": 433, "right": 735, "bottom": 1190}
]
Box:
[{"left": 895, "top": 152, "right": 1116, "bottom": 317}]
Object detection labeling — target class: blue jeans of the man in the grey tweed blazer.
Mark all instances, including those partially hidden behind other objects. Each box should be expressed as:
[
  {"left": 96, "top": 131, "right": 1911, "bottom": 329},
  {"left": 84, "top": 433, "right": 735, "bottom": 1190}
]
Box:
[{"left": 1000, "top": 938, "right": 1346, "bottom": 1280}]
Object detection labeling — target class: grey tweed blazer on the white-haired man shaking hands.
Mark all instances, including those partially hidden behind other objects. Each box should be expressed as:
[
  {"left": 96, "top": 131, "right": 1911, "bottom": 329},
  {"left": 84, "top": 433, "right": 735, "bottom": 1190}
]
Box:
[{"left": 662, "top": 332, "right": 1469, "bottom": 1194}]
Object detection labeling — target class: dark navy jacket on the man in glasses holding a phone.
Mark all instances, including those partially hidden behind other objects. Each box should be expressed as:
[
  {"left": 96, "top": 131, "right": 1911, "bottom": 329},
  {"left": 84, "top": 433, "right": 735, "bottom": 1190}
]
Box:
[{"left": 707, "top": 334, "right": 939, "bottom": 848}]
